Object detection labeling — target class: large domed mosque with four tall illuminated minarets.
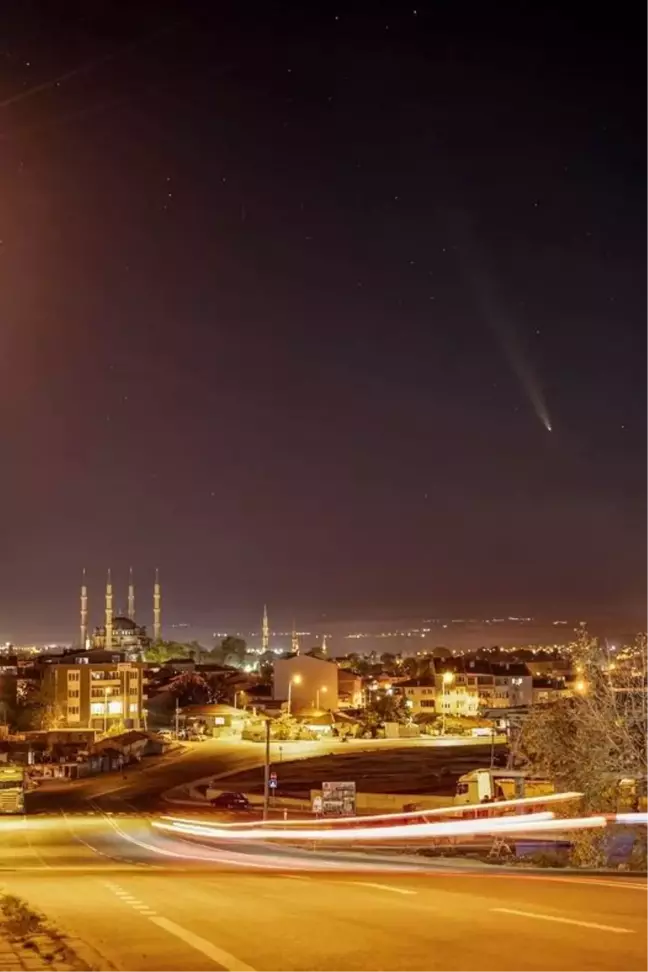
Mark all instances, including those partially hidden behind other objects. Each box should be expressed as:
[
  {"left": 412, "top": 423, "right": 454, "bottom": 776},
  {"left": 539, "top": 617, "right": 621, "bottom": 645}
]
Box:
[{"left": 80, "top": 568, "right": 162, "bottom": 656}]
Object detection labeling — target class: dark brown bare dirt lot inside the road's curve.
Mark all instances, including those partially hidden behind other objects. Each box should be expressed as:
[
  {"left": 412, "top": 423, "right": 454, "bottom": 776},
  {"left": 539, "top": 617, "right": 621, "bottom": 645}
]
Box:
[{"left": 220, "top": 744, "right": 504, "bottom": 799}]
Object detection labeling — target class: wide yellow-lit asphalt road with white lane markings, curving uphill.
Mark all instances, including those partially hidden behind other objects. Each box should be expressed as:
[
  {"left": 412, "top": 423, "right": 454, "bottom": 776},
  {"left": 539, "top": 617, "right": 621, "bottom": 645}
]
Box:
[{"left": 0, "top": 747, "right": 648, "bottom": 972}]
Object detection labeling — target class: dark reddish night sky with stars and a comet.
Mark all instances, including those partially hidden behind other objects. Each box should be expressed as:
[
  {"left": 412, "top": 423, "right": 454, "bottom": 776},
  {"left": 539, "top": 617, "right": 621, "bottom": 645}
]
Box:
[{"left": 0, "top": 7, "right": 648, "bottom": 642}]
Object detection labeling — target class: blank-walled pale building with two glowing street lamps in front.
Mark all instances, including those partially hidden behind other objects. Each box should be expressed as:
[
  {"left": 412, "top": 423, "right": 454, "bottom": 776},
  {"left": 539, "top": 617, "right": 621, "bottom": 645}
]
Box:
[{"left": 273, "top": 654, "right": 339, "bottom": 712}]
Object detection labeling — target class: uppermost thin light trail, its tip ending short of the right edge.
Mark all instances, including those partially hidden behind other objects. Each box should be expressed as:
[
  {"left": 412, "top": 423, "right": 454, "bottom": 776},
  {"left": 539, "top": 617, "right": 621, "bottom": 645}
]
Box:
[{"left": 161, "top": 792, "right": 583, "bottom": 830}]
